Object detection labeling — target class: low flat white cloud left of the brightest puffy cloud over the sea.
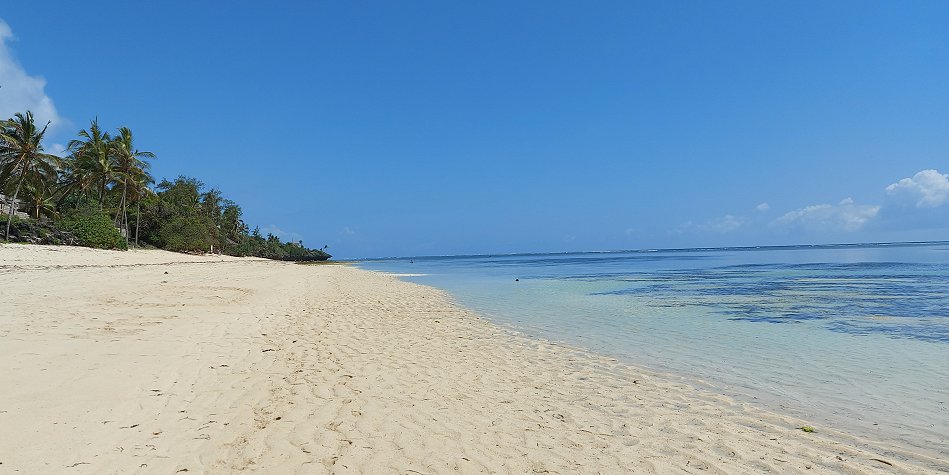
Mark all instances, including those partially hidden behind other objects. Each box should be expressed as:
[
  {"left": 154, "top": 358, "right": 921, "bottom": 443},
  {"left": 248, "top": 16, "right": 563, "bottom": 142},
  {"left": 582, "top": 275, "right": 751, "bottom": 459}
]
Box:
[{"left": 771, "top": 198, "right": 880, "bottom": 232}]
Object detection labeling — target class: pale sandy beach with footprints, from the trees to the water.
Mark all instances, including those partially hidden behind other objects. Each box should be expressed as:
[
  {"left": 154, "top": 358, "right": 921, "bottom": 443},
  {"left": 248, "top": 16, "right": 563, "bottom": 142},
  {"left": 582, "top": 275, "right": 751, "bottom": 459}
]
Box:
[{"left": 0, "top": 245, "right": 949, "bottom": 473}]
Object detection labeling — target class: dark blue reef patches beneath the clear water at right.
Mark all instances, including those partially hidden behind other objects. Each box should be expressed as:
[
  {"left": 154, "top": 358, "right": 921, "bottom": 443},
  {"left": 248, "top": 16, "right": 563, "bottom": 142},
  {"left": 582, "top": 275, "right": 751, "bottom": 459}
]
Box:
[{"left": 584, "top": 262, "right": 949, "bottom": 343}]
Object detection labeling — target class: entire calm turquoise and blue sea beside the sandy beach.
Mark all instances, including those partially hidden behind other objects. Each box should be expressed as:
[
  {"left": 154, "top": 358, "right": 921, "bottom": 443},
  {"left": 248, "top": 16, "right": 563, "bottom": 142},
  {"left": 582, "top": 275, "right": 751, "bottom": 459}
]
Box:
[{"left": 361, "top": 243, "right": 949, "bottom": 459}]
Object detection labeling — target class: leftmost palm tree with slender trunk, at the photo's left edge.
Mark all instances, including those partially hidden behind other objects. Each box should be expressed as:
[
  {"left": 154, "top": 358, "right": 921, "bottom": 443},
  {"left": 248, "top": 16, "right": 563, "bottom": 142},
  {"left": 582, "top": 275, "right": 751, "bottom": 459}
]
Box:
[{"left": 0, "top": 111, "right": 60, "bottom": 240}]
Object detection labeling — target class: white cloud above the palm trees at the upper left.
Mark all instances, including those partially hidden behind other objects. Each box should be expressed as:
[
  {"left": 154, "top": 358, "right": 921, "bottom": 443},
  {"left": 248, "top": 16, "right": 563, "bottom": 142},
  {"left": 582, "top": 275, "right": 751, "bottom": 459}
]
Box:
[{"left": 0, "top": 19, "right": 63, "bottom": 130}]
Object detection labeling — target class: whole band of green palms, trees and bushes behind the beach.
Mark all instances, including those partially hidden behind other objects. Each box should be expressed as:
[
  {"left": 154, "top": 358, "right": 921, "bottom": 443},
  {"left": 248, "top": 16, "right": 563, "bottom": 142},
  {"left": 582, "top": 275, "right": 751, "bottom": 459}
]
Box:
[{"left": 0, "top": 112, "right": 330, "bottom": 261}]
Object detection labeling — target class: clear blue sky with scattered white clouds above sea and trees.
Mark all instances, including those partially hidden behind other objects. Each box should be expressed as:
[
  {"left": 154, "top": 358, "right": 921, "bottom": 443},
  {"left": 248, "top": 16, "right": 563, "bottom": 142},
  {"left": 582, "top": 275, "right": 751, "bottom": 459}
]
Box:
[{"left": 0, "top": 0, "right": 949, "bottom": 258}]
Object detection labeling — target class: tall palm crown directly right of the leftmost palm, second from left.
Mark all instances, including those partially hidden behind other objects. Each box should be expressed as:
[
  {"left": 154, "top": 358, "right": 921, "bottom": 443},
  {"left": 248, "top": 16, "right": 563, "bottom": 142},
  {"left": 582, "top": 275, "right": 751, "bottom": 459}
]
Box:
[{"left": 67, "top": 118, "right": 115, "bottom": 208}]
